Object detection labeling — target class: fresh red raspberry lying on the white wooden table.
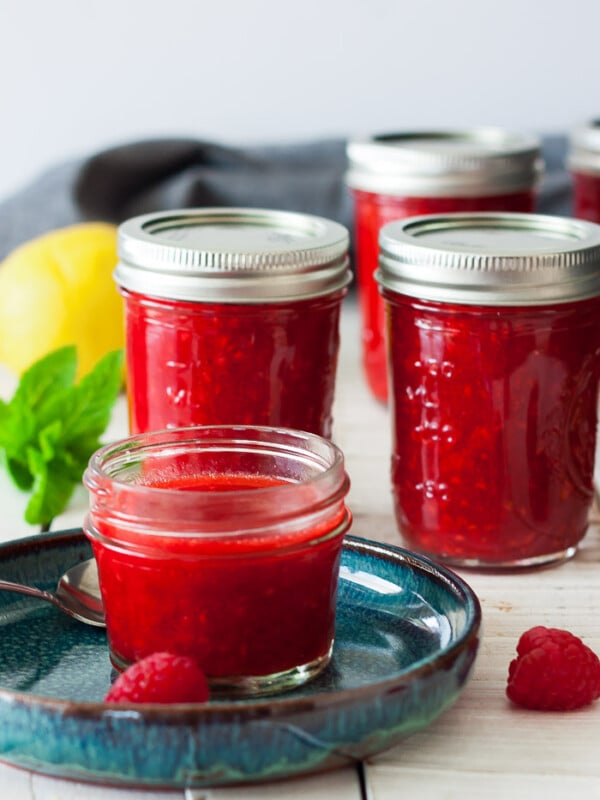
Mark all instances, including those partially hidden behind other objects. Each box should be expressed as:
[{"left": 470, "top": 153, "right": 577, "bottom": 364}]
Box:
[{"left": 506, "top": 625, "right": 600, "bottom": 711}]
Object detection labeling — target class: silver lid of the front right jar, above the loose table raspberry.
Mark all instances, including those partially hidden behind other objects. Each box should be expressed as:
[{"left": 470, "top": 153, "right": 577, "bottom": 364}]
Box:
[{"left": 376, "top": 213, "right": 600, "bottom": 306}]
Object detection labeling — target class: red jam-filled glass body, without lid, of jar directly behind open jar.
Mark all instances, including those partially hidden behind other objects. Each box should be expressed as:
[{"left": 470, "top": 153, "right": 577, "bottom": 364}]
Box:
[{"left": 121, "top": 289, "right": 346, "bottom": 437}]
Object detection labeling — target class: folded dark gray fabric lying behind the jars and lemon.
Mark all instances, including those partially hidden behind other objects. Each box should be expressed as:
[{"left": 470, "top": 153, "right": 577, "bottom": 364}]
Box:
[{"left": 0, "top": 136, "right": 571, "bottom": 258}]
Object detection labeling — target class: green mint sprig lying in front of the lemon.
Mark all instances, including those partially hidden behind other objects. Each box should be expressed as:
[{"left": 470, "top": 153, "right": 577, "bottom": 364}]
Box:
[{"left": 0, "top": 346, "right": 123, "bottom": 529}]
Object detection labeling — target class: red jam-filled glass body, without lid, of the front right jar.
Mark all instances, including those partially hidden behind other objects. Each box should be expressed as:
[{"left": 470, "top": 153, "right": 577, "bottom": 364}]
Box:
[{"left": 384, "top": 290, "right": 600, "bottom": 567}]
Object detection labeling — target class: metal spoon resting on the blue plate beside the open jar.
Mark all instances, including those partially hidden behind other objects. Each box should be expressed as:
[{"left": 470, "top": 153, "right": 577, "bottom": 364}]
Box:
[{"left": 0, "top": 558, "right": 106, "bottom": 628}]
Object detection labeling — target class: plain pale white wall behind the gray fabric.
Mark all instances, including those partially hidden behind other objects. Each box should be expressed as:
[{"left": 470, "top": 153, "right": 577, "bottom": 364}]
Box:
[{"left": 0, "top": 0, "right": 600, "bottom": 197}]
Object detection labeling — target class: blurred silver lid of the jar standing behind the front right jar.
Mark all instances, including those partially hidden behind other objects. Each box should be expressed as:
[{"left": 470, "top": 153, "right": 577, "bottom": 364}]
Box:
[{"left": 346, "top": 128, "right": 543, "bottom": 197}]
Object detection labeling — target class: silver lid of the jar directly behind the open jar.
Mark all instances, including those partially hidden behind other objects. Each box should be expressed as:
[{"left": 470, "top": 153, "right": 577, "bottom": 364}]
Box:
[{"left": 114, "top": 208, "right": 351, "bottom": 303}]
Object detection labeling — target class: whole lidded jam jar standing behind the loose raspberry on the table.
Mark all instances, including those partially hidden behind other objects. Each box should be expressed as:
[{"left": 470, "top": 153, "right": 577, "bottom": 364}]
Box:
[{"left": 377, "top": 209, "right": 600, "bottom": 567}]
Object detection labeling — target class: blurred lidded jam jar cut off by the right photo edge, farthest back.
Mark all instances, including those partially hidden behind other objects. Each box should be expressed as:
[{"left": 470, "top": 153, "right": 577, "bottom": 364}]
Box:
[{"left": 567, "top": 120, "right": 600, "bottom": 222}]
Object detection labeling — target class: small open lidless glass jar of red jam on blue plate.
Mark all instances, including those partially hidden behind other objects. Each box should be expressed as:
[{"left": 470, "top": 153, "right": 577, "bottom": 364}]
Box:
[{"left": 84, "top": 426, "right": 350, "bottom": 695}]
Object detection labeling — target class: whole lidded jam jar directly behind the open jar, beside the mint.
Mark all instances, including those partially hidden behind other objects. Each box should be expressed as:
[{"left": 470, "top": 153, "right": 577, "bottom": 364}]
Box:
[{"left": 115, "top": 208, "right": 350, "bottom": 437}]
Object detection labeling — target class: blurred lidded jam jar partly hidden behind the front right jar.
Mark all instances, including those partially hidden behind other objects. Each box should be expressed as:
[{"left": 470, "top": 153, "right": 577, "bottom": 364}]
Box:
[{"left": 347, "top": 133, "right": 542, "bottom": 402}]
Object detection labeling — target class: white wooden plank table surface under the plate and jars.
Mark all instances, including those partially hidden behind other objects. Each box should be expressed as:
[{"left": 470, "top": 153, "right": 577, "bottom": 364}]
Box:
[{"left": 0, "top": 299, "right": 600, "bottom": 800}]
